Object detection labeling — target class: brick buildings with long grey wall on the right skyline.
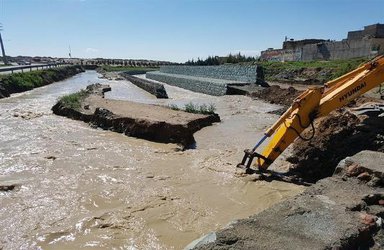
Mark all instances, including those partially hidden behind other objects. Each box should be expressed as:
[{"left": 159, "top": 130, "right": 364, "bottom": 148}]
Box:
[{"left": 260, "top": 23, "right": 384, "bottom": 61}]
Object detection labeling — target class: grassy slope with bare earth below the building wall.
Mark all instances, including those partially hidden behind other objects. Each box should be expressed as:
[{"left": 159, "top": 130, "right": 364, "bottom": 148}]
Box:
[{"left": 257, "top": 58, "right": 369, "bottom": 84}]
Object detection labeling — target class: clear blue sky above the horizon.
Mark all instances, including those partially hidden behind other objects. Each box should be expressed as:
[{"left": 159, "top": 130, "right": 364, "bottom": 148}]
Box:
[{"left": 0, "top": 0, "right": 384, "bottom": 62}]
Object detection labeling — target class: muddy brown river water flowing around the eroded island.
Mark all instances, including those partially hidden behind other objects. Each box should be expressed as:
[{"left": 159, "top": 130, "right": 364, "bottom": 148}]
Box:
[{"left": 0, "top": 71, "right": 302, "bottom": 249}]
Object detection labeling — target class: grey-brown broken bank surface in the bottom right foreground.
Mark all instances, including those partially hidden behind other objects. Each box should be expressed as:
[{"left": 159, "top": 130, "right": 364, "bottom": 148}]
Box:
[{"left": 187, "top": 151, "right": 384, "bottom": 249}]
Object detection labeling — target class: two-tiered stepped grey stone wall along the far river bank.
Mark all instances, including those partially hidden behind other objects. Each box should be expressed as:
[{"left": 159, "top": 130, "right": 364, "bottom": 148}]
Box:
[{"left": 146, "top": 65, "right": 257, "bottom": 96}]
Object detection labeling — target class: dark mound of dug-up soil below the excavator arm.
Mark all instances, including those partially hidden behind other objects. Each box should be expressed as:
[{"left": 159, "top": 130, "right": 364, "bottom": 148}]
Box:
[{"left": 287, "top": 106, "right": 384, "bottom": 182}]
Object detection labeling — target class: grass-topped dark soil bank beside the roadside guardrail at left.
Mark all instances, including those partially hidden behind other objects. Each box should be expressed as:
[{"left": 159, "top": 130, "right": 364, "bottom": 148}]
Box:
[{"left": 0, "top": 65, "right": 84, "bottom": 98}]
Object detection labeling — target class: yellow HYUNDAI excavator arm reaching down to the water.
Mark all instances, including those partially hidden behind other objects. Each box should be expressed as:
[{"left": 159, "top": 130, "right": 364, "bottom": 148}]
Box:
[{"left": 237, "top": 56, "right": 384, "bottom": 173}]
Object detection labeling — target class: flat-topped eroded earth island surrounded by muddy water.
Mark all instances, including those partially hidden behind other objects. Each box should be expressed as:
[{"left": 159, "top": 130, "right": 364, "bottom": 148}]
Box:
[{"left": 52, "top": 84, "right": 220, "bottom": 147}]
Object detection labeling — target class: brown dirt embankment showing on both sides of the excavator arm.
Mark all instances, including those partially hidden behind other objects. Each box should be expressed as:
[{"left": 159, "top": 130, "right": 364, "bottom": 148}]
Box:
[{"left": 246, "top": 82, "right": 384, "bottom": 183}]
